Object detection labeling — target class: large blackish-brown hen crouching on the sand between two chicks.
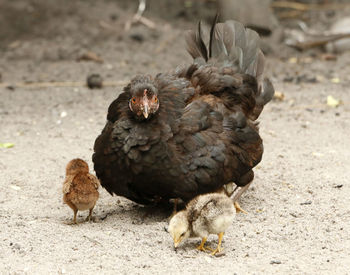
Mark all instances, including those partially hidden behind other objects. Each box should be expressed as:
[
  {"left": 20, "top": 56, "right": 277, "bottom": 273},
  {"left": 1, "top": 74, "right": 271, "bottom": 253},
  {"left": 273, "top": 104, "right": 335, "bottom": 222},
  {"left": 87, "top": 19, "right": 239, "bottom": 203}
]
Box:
[{"left": 93, "top": 18, "right": 274, "bottom": 204}]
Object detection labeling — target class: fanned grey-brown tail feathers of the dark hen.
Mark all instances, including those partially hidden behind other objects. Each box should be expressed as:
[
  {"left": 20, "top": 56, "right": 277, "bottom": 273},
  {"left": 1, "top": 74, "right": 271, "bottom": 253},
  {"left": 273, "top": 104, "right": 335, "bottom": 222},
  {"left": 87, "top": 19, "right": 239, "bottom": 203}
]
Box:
[{"left": 186, "top": 16, "right": 274, "bottom": 118}]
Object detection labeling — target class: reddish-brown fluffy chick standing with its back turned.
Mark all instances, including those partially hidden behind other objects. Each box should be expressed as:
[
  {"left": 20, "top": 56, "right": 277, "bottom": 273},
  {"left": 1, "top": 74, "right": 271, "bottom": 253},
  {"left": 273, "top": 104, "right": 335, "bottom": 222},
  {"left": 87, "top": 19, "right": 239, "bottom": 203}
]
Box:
[{"left": 63, "top": 159, "right": 99, "bottom": 224}]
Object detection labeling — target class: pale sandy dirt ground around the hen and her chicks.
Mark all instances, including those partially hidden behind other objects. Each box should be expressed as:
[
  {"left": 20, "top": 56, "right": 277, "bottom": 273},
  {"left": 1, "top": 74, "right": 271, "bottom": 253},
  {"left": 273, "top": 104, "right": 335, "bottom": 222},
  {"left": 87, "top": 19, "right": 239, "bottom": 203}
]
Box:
[{"left": 0, "top": 1, "right": 350, "bottom": 274}]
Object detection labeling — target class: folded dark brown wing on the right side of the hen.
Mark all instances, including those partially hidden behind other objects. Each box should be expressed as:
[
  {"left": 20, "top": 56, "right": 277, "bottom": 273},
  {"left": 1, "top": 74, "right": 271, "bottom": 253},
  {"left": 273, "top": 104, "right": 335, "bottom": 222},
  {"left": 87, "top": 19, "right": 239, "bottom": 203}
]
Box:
[{"left": 173, "top": 96, "right": 263, "bottom": 200}]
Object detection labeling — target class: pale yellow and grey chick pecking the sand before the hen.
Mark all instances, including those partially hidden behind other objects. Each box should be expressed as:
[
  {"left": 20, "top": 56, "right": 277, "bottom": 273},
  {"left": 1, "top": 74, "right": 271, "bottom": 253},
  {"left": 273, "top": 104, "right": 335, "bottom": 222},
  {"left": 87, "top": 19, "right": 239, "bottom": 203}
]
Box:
[{"left": 168, "top": 193, "right": 236, "bottom": 255}]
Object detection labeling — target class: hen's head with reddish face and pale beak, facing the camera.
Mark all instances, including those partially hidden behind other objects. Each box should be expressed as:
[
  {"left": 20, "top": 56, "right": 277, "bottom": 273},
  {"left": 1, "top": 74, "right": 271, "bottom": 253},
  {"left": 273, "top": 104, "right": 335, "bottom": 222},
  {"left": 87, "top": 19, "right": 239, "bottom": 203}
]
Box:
[{"left": 129, "top": 77, "right": 159, "bottom": 119}]
